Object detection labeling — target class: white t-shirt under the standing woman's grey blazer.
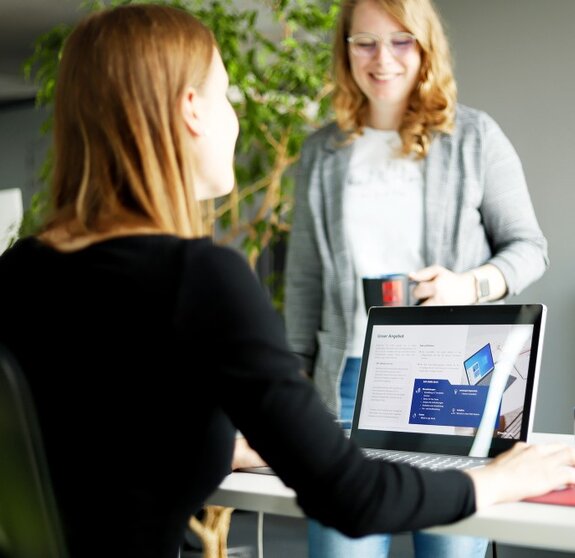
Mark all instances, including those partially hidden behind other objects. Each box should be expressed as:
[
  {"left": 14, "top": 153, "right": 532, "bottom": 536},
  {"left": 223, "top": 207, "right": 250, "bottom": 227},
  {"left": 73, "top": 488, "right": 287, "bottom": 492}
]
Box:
[{"left": 343, "top": 128, "right": 424, "bottom": 356}]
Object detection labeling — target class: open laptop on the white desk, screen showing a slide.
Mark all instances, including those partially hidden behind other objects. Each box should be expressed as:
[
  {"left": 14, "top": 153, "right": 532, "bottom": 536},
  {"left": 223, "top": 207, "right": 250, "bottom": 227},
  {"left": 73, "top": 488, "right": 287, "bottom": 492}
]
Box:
[{"left": 350, "top": 304, "right": 546, "bottom": 469}]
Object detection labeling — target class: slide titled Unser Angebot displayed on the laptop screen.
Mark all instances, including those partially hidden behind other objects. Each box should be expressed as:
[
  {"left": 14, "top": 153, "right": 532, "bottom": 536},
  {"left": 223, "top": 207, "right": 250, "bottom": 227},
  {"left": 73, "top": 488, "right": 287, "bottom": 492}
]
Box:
[{"left": 358, "top": 325, "right": 533, "bottom": 438}]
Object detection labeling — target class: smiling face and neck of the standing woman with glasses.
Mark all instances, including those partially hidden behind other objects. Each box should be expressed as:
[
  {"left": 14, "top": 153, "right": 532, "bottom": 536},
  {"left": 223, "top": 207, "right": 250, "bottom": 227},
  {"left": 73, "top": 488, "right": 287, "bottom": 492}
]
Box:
[{"left": 348, "top": 0, "right": 421, "bottom": 129}]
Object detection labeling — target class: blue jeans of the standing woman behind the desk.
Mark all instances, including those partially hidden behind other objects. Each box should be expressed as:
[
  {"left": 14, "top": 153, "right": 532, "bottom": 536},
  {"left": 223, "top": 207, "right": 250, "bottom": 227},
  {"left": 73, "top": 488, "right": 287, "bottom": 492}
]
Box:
[{"left": 308, "top": 358, "right": 489, "bottom": 558}]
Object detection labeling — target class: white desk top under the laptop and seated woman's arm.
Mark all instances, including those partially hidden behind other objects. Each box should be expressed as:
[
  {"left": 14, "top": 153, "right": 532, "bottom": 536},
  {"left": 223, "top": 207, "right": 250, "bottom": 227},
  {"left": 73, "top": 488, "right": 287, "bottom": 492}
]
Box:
[{"left": 207, "top": 434, "right": 575, "bottom": 551}]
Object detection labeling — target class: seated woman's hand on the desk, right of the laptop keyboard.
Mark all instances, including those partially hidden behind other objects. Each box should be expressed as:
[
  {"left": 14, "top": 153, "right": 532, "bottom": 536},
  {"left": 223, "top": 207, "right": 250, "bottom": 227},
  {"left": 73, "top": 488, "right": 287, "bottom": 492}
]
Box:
[{"left": 466, "top": 442, "right": 575, "bottom": 510}]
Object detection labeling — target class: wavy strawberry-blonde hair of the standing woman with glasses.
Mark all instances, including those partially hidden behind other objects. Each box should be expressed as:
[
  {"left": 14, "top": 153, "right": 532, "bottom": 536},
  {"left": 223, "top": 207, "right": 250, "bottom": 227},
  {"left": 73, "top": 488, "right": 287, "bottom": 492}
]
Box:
[{"left": 333, "top": 0, "right": 457, "bottom": 158}]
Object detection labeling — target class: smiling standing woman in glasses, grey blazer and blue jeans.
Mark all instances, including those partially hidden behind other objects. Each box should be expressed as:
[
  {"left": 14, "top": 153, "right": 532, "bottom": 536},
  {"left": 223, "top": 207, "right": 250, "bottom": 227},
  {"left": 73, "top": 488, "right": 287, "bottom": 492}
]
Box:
[{"left": 286, "top": 0, "right": 548, "bottom": 558}]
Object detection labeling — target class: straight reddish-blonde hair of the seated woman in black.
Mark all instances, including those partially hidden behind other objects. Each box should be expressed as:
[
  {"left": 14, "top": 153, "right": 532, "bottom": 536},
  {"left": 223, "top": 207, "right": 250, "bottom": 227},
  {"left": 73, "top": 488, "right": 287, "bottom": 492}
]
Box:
[{"left": 44, "top": 4, "right": 216, "bottom": 241}]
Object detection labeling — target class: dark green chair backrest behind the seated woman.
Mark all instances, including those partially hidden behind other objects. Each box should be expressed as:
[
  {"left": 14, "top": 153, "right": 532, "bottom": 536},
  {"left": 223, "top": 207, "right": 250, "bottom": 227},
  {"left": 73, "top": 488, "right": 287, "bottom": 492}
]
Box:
[{"left": 0, "top": 344, "right": 68, "bottom": 558}]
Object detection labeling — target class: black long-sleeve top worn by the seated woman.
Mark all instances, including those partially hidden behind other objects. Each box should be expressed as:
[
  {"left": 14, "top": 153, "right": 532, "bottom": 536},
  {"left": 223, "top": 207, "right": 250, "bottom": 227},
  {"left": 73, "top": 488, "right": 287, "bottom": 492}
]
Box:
[{"left": 0, "top": 235, "right": 475, "bottom": 558}]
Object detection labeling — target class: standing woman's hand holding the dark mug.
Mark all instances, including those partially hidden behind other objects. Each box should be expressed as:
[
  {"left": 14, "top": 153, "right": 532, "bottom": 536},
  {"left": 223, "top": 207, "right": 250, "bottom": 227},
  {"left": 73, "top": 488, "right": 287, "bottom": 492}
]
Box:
[{"left": 409, "top": 265, "right": 477, "bottom": 306}]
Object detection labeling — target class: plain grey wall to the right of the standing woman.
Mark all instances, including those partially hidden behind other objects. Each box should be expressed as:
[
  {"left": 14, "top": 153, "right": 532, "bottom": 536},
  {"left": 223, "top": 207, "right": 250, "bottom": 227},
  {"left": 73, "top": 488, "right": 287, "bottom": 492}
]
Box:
[{"left": 435, "top": 0, "right": 575, "bottom": 433}]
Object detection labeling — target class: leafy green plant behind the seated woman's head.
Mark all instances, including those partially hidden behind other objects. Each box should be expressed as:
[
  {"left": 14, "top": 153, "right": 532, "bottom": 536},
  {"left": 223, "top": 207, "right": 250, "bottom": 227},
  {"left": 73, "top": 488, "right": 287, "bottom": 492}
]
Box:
[{"left": 22, "top": 0, "right": 339, "bottom": 306}]
